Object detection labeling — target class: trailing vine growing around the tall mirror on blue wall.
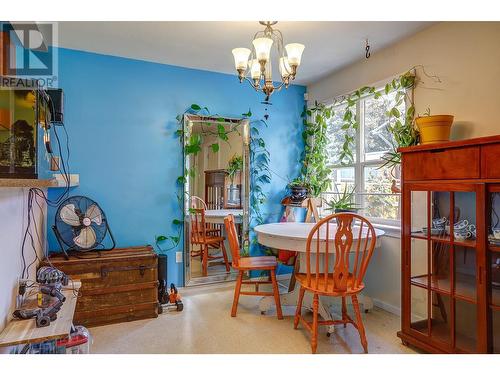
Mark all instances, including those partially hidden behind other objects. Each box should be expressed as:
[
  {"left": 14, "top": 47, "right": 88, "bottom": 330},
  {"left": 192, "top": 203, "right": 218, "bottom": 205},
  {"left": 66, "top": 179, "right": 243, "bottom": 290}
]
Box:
[{"left": 155, "top": 104, "right": 271, "bottom": 253}]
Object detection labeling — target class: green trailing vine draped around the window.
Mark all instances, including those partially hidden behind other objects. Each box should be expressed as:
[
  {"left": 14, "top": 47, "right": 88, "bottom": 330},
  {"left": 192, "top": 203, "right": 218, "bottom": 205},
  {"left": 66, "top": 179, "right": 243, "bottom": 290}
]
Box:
[{"left": 292, "top": 65, "right": 441, "bottom": 196}]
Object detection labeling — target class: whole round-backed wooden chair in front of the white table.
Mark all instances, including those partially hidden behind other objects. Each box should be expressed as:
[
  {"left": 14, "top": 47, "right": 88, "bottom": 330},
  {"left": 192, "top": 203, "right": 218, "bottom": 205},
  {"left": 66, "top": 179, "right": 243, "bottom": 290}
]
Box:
[{"left": 294, "top": 213, "right": 376, "bottom": 354}]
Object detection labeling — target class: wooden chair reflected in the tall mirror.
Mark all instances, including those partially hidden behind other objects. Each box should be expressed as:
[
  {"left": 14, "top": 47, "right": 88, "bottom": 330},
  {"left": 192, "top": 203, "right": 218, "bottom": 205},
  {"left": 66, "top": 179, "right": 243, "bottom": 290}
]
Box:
[{"left": 190, "top": 208, "right": 230, "bottom": 276}]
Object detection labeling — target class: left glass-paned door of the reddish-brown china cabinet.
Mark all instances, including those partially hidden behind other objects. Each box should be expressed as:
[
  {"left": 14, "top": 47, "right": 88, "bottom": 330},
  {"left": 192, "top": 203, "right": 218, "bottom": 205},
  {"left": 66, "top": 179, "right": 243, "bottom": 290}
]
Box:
[{"left": 410, "top": 186, "right": 477, "bottom": 352}]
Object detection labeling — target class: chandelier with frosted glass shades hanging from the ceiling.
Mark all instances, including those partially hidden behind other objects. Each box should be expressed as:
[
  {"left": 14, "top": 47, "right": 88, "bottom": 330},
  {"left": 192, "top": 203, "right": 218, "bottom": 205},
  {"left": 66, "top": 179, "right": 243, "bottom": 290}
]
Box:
[{"left": 232, "top": 21, "right": 304, "bottom": 103}]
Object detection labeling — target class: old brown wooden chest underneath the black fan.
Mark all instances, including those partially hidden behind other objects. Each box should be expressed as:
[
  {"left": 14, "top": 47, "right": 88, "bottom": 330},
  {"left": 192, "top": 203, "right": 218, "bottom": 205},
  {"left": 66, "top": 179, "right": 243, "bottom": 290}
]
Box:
[{"left": 42, "top": 246, "right": 158, "bottom": 327}]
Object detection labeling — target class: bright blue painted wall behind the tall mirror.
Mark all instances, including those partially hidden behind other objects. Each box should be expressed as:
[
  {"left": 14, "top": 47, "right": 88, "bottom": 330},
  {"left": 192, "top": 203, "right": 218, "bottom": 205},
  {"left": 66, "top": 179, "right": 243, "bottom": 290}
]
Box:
[{"left": 48, "top": 49, "right": 305, "bottom": 284}]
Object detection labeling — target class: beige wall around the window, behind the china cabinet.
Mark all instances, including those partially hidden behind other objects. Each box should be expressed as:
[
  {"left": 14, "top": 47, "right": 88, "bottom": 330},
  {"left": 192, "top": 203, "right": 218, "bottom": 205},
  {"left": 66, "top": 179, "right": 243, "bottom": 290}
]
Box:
[{"left": 307, "top": 22, "right": 500, "bottom": 312}]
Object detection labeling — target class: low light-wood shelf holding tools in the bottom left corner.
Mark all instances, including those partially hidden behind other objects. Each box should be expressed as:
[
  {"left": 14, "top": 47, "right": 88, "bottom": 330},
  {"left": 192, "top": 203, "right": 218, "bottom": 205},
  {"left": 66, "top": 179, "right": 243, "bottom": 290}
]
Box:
[{"left": 0, "top": 281, "right": 81, "bottom": 347}]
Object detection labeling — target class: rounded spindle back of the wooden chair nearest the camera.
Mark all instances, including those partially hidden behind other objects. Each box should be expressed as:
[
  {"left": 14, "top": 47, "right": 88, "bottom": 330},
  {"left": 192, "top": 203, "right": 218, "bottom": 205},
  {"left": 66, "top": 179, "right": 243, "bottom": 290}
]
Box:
[{"left": 306, "top": 213, "right": 376, "bottom": 293}]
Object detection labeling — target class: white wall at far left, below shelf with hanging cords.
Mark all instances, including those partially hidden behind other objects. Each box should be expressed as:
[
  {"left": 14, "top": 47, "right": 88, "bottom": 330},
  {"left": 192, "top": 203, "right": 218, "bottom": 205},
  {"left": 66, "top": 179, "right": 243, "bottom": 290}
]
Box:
[{"left": 0, "top": 188, "right": 46, "bottom": 352}]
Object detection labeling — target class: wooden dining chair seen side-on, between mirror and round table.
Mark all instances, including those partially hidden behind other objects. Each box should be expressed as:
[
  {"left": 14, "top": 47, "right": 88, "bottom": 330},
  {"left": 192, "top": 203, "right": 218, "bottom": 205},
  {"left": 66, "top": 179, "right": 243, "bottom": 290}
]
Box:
[{"left": 224, "top": 215, "right": 283, "bottom": 320}]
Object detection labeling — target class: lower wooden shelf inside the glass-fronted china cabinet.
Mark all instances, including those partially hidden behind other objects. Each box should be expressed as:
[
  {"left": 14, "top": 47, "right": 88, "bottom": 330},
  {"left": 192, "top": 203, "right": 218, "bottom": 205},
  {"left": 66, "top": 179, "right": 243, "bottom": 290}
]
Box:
[{"left": 410, "top": 273, "right": 478, "bottom": 303}]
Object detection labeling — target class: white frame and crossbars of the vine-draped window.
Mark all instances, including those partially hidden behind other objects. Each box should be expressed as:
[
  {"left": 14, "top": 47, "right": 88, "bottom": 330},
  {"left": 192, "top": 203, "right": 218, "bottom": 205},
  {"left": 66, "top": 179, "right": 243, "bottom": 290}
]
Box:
[{"left": 325, "top": 87, "right": 401, "bottom": 229}]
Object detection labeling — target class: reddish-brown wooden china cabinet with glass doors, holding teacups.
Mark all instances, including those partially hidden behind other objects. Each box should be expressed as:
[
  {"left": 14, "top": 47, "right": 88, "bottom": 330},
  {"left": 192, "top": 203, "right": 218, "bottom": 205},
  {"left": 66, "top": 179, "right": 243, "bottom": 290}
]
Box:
[{"left": 398, "top": 136, "right": 500, "bottom": 353}]
